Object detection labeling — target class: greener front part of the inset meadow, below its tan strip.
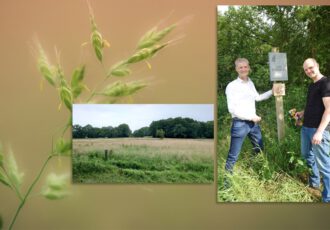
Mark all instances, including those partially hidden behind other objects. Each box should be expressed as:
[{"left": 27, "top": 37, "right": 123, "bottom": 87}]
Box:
[{"left": 72, "top": 144, "right": 213, "bottom": 183}]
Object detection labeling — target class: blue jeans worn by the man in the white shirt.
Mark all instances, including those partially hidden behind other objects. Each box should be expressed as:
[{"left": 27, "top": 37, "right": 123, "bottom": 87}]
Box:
[{"left": 225, "top": 118, "right": 263, "bottom": 172}]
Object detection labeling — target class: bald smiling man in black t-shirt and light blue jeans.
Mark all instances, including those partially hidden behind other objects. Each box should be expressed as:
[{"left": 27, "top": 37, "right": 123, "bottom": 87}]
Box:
[{"left": 296, "top": 58, "right": 330, "bottom": 202}]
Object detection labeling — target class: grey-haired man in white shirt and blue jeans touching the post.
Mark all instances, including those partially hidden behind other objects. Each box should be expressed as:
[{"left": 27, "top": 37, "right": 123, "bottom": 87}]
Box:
[{"left": 225, "top": 58, "right": 273, "bottom": 172}]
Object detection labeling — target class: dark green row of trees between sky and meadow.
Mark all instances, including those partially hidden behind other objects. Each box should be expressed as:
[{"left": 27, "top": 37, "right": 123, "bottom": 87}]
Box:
[{"left": 72, "top": 117, "right": 213, "bottom": 138}]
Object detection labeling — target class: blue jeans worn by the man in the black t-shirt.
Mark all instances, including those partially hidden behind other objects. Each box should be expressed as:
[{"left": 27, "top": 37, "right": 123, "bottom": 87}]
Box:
[{"left": 301, "top": 126, "right": 330, "bottom": 202}]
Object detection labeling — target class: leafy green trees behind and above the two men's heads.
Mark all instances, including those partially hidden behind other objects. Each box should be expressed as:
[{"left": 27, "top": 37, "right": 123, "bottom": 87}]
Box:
[{"left": 218, "top": 6, "right": 330, "bottom": 93}]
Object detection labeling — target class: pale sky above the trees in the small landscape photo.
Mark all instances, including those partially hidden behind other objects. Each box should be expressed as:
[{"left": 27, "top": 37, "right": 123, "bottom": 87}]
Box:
[{"left": 72, "top": 104, "right": 214, "bottom": 131}]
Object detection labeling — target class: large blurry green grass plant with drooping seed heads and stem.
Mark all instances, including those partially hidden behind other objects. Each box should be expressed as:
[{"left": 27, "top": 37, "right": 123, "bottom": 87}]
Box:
[{"left": 0, "top": 3, "right": 178, "bottom": 229}]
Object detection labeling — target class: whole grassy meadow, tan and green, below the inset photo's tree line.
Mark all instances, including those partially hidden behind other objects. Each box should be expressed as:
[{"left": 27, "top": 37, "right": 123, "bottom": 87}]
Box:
[{"left": 72, "top": 138, "right": 214, "bottom": 183}]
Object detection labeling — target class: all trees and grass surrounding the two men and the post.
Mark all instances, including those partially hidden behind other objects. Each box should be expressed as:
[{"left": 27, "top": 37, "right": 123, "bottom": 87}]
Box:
[{"left": 217, "top": 6, "right": 330, "bottom": 202}]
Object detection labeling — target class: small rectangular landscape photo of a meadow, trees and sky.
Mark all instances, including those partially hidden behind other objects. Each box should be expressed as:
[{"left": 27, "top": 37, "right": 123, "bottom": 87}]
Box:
[{"left": 72, "top": 104, "right": 214, "bottom": 184}]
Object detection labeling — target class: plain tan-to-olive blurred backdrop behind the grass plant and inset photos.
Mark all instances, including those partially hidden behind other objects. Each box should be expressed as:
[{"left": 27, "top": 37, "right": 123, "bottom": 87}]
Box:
[{"left": 0, "top": 0, "right": 330, "bottom": 229}]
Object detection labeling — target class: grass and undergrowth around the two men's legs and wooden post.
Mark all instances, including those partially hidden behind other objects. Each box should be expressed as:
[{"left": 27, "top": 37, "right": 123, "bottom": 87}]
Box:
[{"left": 217, "top": 87, "right": 320, "bottom": 202}]
